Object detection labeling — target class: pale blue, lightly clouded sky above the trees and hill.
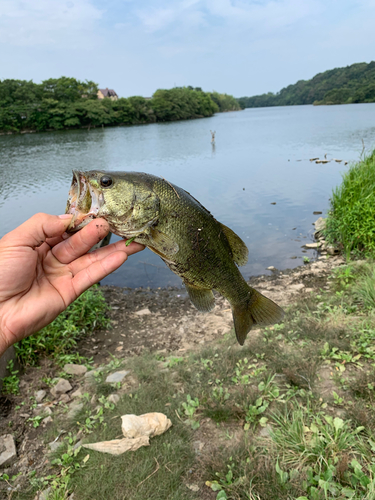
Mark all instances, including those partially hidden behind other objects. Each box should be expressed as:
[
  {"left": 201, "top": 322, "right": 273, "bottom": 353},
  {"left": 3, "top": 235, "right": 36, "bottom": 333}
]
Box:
[{"left": 0, "top": 0, "right": 375, "bottom": 97}]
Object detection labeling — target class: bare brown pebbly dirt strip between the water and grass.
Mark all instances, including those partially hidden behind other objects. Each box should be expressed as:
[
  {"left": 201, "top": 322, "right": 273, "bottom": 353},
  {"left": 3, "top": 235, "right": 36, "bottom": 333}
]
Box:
[{"left": 0, "top": 256, "right": 344, "bottom": 498}]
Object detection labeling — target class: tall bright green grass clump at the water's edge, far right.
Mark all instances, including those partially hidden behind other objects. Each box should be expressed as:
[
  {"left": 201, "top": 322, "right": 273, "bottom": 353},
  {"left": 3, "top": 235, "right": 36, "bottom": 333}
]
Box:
[{"left": 325, "top": 151, "right": 375, "bottom": 257}]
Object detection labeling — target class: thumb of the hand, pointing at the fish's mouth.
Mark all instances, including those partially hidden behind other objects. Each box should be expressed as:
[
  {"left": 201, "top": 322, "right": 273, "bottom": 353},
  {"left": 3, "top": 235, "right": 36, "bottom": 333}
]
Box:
[{"left": 2, "top": 213, "right": 72, "bottom": 248}]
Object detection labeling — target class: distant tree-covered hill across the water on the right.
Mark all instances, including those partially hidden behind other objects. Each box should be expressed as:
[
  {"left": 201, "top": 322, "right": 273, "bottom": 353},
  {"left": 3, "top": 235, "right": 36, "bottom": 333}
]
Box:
[{"left": 238, "top": 61, "right": 375, "bottom": 108}]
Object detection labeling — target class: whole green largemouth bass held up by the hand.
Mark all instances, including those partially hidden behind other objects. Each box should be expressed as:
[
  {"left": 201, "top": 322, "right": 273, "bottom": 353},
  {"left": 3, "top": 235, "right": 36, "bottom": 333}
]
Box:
[{"left": 66, "top": 170, "right": 284, "bottom": 345}]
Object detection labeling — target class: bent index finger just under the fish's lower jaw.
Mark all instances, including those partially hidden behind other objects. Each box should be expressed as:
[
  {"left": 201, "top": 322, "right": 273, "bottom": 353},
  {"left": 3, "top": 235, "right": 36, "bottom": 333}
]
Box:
[{"left": 52, "top": 219, "right": 109, "bottom": 264}]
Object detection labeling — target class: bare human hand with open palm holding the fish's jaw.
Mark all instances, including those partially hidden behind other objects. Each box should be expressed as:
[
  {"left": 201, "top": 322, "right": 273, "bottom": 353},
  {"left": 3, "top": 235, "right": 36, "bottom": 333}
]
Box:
[{"left": 0, "top": 213, "right": 144, "bottom": 356}]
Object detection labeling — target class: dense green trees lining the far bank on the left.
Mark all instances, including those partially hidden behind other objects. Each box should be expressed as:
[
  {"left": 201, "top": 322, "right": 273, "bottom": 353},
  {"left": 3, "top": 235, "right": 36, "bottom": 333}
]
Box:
[{"left": 0, "top": 77, "right": 241, "bottom": 133}]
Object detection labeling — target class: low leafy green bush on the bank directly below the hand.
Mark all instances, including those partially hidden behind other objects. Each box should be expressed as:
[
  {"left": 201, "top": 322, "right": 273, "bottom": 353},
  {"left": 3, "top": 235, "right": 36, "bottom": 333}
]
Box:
[{"left": 15, "top": 286, "right": 110, "bottom": 365}]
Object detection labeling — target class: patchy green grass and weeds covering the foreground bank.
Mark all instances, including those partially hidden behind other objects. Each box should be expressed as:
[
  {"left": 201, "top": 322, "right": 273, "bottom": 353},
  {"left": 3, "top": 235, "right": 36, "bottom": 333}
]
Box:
[{"left": 8, "top": 261, "right": 375, "bottom": 500}]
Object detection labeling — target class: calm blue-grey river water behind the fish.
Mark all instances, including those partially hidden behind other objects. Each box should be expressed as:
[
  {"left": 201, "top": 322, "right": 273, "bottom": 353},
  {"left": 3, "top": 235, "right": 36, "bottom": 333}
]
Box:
[{"left": 0, "top": 104, "right": 375, "bottom": 288}]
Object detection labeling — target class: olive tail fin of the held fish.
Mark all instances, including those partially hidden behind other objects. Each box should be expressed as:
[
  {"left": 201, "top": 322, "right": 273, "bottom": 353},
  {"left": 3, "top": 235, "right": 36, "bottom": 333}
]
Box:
[{"left": 232, "top": 288, "right": 284, "bottom": 345}]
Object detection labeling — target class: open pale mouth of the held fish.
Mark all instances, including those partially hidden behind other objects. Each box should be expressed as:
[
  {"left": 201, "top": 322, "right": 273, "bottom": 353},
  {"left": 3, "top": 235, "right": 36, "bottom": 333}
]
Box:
[{"left": 65, "top": 170, "right": 104, "bottom": 233}]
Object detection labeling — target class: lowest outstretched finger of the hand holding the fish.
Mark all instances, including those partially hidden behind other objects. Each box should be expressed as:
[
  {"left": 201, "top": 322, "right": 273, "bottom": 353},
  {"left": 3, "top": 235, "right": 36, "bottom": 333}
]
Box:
[{"left": 72, "top": 251, "right": 128, "bottom": 297}]
